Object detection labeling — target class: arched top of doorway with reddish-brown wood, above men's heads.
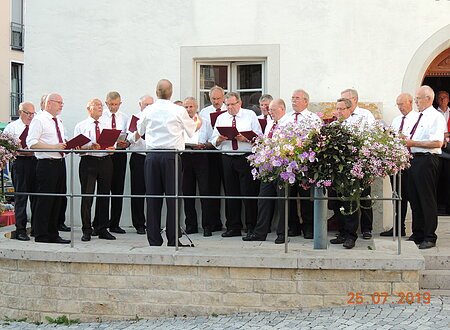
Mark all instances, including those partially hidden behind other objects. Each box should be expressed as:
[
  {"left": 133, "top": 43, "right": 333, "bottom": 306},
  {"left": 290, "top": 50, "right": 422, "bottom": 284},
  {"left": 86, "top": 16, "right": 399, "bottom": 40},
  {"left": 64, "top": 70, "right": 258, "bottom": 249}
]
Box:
[{"left": 422, "top": 48, "right": 450, "bottom": 108}]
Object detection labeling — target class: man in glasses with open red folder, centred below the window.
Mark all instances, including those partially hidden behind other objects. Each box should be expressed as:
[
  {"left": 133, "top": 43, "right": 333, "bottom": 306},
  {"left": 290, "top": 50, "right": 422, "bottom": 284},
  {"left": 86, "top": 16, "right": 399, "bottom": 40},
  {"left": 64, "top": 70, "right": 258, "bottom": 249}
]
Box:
[{"left": 210, "top": 92, "right": 262, "bottom": 237}]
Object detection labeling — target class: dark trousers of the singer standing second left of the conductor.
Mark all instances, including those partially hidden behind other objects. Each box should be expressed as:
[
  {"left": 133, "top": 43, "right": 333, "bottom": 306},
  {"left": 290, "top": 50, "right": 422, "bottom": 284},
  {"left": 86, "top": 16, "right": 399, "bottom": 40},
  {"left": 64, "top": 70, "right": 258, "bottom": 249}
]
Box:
[{"left": 109, "top": 153, "right": 127, "bottom": 228}]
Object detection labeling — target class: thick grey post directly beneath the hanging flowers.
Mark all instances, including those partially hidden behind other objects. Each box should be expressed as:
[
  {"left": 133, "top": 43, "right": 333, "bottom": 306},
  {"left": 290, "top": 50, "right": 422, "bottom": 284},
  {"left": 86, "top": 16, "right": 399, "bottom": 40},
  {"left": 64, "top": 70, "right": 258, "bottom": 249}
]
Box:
[{"left": 314, "top": 187, "right": 328, "bottom": 250}]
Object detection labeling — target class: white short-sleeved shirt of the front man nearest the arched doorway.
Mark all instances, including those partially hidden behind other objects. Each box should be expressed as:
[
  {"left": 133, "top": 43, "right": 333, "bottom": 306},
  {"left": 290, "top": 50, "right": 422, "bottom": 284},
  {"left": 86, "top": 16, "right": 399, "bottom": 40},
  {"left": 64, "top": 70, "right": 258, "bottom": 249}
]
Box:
[{"left": 409, "top": 106, "right": 447, "bottom": 155}]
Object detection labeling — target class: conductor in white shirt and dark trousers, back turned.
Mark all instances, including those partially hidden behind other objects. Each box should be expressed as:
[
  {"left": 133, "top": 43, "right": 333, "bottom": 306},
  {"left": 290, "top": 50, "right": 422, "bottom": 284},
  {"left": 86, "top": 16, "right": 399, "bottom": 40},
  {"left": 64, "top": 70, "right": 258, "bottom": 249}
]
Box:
[{"left": 136, "top": 79, "right": 197, "bottom": 246}]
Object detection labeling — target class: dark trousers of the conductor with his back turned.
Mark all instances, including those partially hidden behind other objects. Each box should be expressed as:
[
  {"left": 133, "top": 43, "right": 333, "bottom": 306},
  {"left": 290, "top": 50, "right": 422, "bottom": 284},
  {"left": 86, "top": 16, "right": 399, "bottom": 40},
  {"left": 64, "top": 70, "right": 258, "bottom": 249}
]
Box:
[{"left": 144, "top": 152, "right": 182, "bottom": 246}]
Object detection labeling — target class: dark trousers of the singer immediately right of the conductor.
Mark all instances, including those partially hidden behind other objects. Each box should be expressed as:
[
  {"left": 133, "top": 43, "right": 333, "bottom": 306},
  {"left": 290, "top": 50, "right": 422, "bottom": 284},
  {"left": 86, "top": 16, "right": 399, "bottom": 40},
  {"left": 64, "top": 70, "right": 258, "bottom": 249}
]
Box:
[{"left": 181, "top": 153, "right": 213, "bottom": 229}]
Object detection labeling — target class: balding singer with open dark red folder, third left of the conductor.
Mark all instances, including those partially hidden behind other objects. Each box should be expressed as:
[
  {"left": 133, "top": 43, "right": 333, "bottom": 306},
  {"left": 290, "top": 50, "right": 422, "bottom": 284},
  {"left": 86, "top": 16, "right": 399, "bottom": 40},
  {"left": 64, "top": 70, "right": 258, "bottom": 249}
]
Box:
[{"left": 74, "top": 99, "right": 116, "bottom": 242}]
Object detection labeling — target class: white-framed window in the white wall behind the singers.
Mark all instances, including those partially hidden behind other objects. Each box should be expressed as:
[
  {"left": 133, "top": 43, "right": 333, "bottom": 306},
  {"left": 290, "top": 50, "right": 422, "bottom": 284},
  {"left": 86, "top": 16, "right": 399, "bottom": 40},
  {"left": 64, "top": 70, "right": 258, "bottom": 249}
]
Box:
[{"left": 196, "top": 61, "right": 265, "bottom": 110}]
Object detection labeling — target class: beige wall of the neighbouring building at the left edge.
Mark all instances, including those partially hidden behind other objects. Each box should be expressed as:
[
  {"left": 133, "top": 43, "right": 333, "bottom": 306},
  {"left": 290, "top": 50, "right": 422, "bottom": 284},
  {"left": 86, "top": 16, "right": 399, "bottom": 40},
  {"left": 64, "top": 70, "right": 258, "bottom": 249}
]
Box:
[{"left": 0, "top": 0, "right": 23, "bottom": 122}]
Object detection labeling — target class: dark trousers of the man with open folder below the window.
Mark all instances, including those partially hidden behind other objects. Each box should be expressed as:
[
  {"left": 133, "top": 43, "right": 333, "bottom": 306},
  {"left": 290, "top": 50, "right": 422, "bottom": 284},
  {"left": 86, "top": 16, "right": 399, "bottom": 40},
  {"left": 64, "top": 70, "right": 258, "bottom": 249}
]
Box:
[{"left": 222, "top": 155, "right": 258, "bottom": 230}]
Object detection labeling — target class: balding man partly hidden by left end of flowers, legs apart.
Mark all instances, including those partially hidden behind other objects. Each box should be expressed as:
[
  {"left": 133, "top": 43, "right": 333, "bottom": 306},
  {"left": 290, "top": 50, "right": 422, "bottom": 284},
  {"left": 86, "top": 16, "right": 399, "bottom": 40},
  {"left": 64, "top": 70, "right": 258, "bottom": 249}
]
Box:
[{"left": 242, "top": 99, "right": 289, "bottom": 243}]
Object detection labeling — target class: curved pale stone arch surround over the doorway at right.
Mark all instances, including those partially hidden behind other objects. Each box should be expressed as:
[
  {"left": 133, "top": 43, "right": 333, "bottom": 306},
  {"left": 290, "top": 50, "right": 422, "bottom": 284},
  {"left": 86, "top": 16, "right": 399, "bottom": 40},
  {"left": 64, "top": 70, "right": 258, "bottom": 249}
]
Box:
[{"left": 402, "top": 24, "right": 450, "bottom": 93}]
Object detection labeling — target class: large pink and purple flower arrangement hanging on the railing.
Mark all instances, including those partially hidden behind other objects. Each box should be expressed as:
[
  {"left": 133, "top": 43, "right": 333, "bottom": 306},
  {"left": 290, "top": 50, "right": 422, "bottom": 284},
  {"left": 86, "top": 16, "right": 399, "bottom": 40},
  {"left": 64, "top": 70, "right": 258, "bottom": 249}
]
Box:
[{"left": 248, "top": 121, "right": 410, "bottom": 211}]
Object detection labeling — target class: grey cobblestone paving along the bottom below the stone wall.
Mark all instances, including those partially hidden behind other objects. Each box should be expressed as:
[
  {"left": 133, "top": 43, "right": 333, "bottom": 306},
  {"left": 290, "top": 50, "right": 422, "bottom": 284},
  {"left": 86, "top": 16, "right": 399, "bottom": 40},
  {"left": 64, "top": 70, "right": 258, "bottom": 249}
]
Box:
[{"left": 0, "top": 296, "right": 450, "bottom": 330}]
